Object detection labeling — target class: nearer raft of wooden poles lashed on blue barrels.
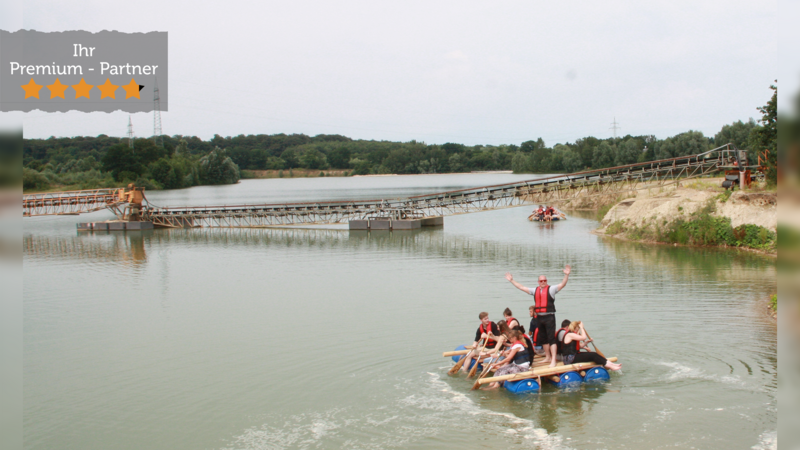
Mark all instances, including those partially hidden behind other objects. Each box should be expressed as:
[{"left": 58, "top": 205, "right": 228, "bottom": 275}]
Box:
[{"left": 442, "top": 345, "right": 617, "bottom": 394}]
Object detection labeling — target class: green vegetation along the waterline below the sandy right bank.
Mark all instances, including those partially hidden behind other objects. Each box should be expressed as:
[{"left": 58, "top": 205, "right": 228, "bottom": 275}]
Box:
[{"left": 605, "top": 199, "right": 777, "bottom": 252}]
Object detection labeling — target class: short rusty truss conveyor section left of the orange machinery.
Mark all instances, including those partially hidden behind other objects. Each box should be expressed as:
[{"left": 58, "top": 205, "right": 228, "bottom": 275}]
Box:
[{"left": 22, "top": 189, "right": 124, "bottom": 217}]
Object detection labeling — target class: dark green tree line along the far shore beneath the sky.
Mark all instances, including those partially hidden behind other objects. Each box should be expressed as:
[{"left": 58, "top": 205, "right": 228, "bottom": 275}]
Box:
[{"left": 23, "top": 86, "right": 777, "bottom": 189}]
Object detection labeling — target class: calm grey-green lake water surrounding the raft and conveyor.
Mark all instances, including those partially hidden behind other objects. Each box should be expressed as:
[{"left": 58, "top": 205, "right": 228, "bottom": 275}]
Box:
[{"left": 23, "top": 174, "right": 778, "bottom": 450}]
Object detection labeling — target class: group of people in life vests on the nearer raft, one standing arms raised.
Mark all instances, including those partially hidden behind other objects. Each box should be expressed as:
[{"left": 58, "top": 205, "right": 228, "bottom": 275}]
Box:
[{"left": 461, "top": 265, "right": 622, "bottom": 389}]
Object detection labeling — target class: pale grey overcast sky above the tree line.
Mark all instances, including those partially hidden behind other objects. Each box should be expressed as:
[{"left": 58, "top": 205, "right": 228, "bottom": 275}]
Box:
[{"left": 0, "top": 0, "right": 776, "bottom": 145}]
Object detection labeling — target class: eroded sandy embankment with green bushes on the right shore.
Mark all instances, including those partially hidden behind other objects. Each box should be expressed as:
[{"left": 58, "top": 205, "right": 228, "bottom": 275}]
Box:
[{"left": 595, "top": 185, "right": 778, "bottom": 254}]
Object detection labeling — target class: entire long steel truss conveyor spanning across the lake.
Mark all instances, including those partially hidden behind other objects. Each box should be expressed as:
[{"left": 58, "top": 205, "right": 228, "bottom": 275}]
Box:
[{"left": 23, "top": 146, "right": 752, "bottom": 228}]
